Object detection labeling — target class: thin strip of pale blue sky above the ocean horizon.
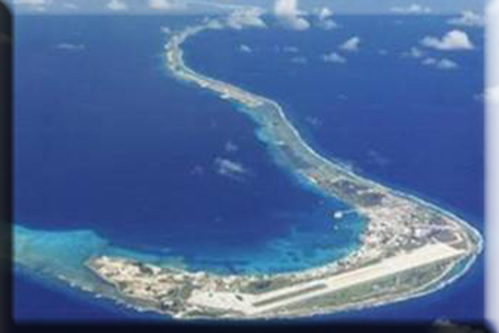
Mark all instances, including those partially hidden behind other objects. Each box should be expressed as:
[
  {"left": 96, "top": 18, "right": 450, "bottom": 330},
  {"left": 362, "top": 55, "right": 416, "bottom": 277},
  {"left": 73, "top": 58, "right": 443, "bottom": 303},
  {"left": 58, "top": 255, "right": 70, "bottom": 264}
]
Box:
[{"left": 0, "top": 0, "right": 486, "bottom": 15}]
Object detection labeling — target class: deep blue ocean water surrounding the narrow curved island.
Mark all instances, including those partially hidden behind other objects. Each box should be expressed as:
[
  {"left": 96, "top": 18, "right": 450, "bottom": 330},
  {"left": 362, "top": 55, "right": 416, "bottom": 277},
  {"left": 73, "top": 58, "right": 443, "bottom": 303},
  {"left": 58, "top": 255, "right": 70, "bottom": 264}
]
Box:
[{"left": 14, "top": 16, "right": 484, "bottom": 320}]
